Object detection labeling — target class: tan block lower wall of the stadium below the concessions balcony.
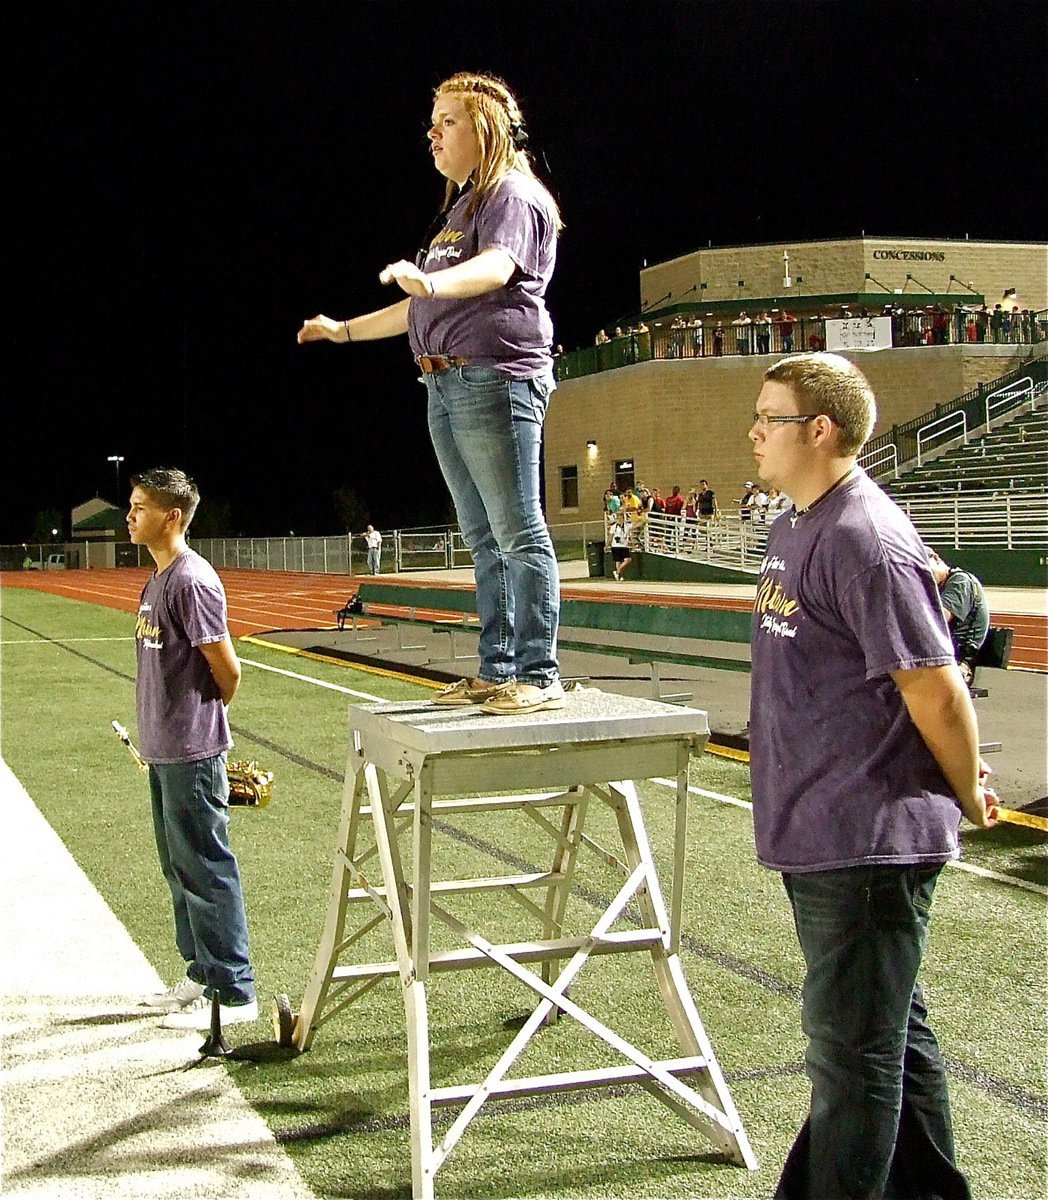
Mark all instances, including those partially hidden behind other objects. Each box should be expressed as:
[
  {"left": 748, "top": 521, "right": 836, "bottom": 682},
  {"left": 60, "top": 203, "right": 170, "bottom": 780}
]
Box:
[{"left": 545, "top": 346, "right": 1029, "bottom": 524}]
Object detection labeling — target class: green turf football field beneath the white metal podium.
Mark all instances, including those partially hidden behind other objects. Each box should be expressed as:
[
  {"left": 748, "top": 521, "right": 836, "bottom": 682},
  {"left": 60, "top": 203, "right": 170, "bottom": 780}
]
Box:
[{"left": 0, "top": 589, "right": 1048, "bottom": 1200}]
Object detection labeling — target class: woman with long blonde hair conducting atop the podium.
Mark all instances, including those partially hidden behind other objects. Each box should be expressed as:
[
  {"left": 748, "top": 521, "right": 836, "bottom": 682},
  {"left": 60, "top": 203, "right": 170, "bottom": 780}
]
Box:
[{"left": 298, "top": 72, "right": 564, "bottom": 715}]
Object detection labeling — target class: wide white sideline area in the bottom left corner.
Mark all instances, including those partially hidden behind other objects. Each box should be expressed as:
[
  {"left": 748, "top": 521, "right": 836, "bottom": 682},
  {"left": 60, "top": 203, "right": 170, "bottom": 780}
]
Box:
[{"left": 0, "top": 758, "right": 313, "bottom": 1200}]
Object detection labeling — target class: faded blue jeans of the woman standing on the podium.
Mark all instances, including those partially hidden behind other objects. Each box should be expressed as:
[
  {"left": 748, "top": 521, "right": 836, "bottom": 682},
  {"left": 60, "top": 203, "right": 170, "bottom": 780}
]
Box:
[{"left": 424, "top": 366, "right": 561, "bottom": 688}]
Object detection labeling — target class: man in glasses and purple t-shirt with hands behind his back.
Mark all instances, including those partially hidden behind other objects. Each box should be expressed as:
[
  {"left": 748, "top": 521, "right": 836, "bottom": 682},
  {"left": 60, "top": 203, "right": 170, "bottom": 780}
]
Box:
[{"left": 749, "top": 354, "right": 996, "bottom": 1200}]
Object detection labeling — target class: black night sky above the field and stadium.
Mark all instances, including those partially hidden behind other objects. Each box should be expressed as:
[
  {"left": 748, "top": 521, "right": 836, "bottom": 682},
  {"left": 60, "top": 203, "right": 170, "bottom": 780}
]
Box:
[{"left": 8, "top": 0, "right": 1048, "bottom": 542}]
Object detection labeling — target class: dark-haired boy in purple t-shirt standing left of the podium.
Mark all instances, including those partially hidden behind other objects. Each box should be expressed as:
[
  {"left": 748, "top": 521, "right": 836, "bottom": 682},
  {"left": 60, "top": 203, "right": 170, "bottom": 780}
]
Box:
[{"left": 127, "top": 468, "right": 258, "bottom": 1030}]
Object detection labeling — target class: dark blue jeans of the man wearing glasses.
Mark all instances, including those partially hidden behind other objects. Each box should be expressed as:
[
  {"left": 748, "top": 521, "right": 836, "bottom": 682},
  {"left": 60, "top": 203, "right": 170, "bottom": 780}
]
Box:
[{"left": 775, "top": 865, "right": 970, "bottom": 1200}]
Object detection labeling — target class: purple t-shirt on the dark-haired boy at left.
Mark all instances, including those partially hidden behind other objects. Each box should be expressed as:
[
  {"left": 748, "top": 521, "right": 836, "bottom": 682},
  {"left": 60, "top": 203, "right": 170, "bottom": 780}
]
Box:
[{"left": 134, "top": 550, "right": 233, "bottom": 763}]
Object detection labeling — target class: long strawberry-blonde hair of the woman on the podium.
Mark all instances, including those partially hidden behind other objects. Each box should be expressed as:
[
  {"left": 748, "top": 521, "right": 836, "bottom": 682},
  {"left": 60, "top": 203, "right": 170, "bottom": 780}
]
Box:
[{"left": 433, "top": 71, "right": 564, "bottom": 232}]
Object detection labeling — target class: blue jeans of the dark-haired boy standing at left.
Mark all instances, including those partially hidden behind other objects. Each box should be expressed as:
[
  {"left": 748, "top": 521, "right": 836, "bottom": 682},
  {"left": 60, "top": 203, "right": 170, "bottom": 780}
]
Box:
[{"left": 149, "top": 754, "right": 254, "bottom": 1004}]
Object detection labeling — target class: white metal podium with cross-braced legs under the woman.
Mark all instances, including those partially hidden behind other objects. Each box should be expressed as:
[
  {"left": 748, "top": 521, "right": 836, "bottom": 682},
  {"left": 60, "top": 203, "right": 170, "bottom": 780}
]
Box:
[{"left": 276, "top": 689, "right": 756, "bottom": 1198}]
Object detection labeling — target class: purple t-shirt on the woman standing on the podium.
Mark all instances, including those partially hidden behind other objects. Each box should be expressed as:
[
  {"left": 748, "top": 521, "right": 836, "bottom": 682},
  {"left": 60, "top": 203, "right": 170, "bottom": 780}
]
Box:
[{"left": 408, "top": 170, "right": 557, "bottom": 379}]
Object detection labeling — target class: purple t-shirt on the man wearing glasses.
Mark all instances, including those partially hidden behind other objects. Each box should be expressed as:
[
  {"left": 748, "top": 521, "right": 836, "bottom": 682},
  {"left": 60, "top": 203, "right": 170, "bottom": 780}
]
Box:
[{"left": 749, "top": 469, "right": 960, "bottom": 871}]
